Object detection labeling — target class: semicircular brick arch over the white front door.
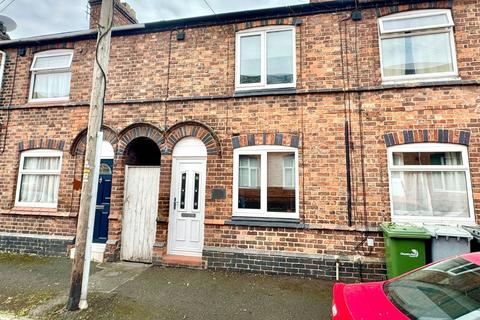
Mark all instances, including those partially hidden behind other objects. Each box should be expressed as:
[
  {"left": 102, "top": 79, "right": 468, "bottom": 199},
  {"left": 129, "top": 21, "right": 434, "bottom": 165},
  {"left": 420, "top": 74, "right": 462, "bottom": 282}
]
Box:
[{"left": 161, "top": 120, "right": 222, "bottom": 155}]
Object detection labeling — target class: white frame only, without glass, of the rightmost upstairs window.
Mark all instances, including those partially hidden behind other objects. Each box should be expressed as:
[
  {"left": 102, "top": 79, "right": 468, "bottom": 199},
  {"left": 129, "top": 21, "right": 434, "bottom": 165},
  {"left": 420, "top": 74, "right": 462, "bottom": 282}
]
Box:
[{"left": 377, "top": 9, "right": 459, "bottom": 84}]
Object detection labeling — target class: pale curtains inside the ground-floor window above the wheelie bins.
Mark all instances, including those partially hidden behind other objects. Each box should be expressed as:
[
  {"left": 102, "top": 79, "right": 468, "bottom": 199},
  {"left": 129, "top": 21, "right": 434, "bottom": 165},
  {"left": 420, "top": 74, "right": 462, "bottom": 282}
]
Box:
[{"left": 391, "top": 153, "right": 469, "bottom": 217}]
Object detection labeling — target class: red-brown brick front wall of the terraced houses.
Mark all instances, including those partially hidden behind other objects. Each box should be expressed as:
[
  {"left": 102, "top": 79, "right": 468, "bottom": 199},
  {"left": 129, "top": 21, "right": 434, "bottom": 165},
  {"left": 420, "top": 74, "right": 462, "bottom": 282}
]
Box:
[{"left": 0, "top": 0, "right": 480, "bottom": 277}]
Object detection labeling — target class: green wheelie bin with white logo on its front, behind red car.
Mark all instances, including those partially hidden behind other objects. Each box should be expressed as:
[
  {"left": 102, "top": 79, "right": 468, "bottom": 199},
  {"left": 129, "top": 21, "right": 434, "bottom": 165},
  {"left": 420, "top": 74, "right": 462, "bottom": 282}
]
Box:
[{"left": 380, "top": 222, "right": 431, "bottom": 279}]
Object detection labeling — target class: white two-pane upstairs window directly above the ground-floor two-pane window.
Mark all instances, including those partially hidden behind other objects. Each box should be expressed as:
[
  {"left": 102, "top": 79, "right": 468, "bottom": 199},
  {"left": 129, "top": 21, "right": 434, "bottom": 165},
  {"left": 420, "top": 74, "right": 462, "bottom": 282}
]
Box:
[{"left": 235, "top": 26, "right": 296, "bottom": 90}]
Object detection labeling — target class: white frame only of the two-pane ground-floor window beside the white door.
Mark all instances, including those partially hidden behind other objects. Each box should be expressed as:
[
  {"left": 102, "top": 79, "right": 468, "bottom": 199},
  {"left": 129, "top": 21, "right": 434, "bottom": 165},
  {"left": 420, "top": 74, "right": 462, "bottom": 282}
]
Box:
[{"left": 232, "top": 145, "right": 300, "bottom": 219}]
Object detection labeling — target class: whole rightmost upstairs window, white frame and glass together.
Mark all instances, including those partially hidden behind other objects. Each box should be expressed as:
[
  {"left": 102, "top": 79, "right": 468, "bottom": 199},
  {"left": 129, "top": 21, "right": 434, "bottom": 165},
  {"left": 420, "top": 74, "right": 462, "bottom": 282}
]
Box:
[{"left": 378, "top": 9, "right": 458, "bottom": 83}]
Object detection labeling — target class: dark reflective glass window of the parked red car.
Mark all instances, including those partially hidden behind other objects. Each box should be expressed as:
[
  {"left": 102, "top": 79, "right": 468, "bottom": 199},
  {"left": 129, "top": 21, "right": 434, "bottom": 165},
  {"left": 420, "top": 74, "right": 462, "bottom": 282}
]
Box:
[{"left": 384, "top": 258, "right": 480, "bottom": 320}]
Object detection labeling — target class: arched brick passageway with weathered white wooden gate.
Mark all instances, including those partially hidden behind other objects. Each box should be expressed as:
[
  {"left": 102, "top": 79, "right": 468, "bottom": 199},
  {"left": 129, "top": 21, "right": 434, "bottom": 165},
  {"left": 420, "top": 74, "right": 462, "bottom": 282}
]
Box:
[{"left": 119, "top": 124, "right": 163, "bottom": 263}]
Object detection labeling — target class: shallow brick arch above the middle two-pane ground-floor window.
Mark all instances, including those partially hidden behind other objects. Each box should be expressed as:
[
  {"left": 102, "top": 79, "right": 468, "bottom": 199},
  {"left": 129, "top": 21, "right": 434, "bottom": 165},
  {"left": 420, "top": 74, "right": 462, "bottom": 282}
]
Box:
[{"left": 232, "top": 132, "right": 300, "bottom": 149}]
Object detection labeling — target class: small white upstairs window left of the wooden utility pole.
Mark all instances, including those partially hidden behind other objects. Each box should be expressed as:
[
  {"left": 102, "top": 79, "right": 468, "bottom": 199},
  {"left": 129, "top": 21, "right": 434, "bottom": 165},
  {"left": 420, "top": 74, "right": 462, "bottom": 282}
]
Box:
[{"left": 29, "top": 50, "right": 73, "bottom": 102}]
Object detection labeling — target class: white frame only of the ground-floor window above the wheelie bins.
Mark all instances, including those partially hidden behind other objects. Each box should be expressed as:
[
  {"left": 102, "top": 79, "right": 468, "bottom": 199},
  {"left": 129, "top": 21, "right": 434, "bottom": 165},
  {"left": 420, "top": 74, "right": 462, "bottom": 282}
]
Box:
[{"left": 387, "top": 143, "right": 475, "bottom": 225}]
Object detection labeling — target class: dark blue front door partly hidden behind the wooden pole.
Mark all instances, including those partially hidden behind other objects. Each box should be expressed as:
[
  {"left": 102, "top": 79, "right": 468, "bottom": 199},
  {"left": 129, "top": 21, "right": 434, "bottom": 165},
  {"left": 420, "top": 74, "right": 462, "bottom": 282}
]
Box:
[{"left": 93, "top": 159, "right": 113, "bottom": 243}]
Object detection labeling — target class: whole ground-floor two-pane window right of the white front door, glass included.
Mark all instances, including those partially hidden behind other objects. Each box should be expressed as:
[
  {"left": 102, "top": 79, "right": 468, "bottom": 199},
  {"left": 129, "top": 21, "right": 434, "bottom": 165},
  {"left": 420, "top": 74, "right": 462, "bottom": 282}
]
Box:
[{"left": 233, "top": 146, "right": 299, "bottom": 219}]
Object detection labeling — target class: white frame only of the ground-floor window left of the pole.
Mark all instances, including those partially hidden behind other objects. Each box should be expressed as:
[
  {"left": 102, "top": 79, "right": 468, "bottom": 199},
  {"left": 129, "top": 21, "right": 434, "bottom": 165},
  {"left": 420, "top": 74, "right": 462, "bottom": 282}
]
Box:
[{"left": 15, "top": 149, "right": 63, "bottom": 208}]
